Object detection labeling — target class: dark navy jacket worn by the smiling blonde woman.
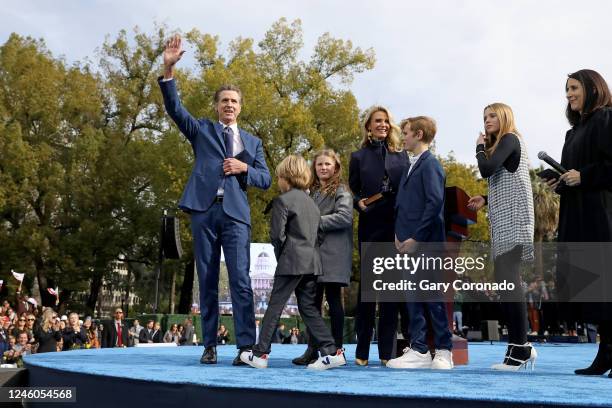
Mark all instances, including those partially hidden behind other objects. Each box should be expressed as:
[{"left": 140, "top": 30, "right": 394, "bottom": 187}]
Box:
[{"left": 349, "top": 144, "right": 410, "bottom": 242}]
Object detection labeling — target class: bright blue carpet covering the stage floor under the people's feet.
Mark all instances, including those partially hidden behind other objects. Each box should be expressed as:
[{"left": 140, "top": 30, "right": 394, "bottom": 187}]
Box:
[{"left": 26, "top": 343, "right": 612, "bottom": 406}]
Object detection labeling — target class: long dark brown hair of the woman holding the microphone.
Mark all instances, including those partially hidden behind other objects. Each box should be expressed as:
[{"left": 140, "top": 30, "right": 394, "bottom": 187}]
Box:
[{"left": 565, "top": 69, "right": 612, "bottom": 126}]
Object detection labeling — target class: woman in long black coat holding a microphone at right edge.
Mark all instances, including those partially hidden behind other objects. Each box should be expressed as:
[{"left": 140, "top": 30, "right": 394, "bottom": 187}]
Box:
[{"left": 549, "top": 69, "right": 612, "bottom": 377}]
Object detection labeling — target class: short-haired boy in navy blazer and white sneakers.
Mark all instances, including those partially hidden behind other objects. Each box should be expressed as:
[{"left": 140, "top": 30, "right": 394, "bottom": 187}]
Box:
[{"left": 387, "top": 116, "right": 453, "bottom": 370}]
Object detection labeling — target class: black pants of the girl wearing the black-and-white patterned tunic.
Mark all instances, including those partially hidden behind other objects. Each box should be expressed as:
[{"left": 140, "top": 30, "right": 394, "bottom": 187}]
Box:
[{"left": 494, "top": 245, "right": 527, "bottom": 344}]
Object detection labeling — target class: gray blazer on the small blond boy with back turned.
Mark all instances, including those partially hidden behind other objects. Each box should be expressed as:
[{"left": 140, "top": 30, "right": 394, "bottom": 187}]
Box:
[{"left": 270, "top": 188, "right": 321, "bottom": 275}]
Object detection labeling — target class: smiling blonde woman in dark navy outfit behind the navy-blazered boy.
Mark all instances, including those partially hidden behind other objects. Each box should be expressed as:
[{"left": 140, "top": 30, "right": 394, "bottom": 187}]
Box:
[{"left": 349, "top": 106, "right": 409, "bottom": 365}]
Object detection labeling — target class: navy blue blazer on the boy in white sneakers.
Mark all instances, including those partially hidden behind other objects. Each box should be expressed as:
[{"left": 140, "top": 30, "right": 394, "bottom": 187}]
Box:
[{"left": 395, "top": 150, "right": 446, "bottom": 242}]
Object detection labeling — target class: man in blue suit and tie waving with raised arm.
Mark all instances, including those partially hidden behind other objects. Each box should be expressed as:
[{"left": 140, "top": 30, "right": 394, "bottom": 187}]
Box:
[{"left": 159, "top": 35, "right": 271, "bottom": 365}]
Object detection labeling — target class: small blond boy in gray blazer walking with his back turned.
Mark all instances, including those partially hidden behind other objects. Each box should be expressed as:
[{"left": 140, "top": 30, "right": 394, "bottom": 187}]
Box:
[{"left": 240, "top": 155, "right": 346, "bottom": 370}]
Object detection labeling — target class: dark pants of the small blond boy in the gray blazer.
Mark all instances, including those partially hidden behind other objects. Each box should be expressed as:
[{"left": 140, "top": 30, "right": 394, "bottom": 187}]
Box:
[{"left": 253, "top": 275, "right": 337, "bottom": 357}]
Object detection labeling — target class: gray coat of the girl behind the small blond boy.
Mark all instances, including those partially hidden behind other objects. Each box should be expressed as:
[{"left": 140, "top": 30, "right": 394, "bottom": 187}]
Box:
[{"left": 312, "top": 185, "right": 353, "bottom": 286}]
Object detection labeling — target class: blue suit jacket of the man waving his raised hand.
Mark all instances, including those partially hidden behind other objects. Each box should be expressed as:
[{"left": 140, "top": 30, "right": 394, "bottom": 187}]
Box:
[{"left": 159, "top": 78, "right": 272, "bottom": 225}]
